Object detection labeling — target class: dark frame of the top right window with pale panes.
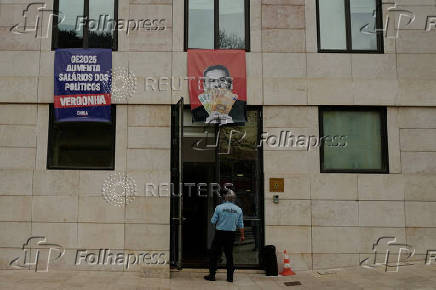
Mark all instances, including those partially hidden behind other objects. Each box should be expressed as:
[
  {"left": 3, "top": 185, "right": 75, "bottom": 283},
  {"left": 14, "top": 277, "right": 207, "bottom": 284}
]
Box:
[{"left": 316, "top": 0, "right": 384, "bottom": 54}]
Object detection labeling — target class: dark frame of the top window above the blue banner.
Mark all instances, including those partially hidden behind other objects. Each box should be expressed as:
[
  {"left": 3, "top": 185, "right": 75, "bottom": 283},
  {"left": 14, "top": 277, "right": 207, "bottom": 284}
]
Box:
[{"left": 51, "top": 0, "right": 118, "bottom": 51}]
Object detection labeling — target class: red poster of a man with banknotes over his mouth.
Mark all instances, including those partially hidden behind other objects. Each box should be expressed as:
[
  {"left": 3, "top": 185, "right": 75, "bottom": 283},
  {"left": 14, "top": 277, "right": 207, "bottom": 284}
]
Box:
[{"left": 188, "top": 49, "right": 247, "bottom": 124}]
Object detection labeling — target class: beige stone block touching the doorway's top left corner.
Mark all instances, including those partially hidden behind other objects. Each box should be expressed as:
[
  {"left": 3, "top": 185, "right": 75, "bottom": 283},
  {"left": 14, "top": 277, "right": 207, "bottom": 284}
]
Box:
[{"left": 127, "top": 105, "right": 171, "bottom": 127}]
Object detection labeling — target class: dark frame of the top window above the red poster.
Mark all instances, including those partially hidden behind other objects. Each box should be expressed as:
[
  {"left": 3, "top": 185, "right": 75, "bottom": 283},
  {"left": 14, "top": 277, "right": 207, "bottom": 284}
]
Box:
[{"left": 184, "top": 0, "right": 251, "bottom": 52}]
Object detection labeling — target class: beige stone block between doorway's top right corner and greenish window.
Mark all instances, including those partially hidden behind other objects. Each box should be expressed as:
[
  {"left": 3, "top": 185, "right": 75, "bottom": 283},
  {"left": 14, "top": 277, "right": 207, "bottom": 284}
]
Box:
[{"left": 263, "top": 106, "right": 318, "bottom": 128}]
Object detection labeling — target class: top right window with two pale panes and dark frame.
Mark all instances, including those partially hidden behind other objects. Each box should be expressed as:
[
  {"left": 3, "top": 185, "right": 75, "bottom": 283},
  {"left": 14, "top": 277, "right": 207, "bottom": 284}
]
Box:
[{"left": 317, "top": 0, "right": 383, "bottom": 53}]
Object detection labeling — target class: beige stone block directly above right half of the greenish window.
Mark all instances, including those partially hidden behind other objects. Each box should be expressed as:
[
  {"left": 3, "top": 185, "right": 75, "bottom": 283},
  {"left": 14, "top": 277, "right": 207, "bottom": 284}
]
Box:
[{"left": 353, "top": 79, "right": 400, "bottom": 106}]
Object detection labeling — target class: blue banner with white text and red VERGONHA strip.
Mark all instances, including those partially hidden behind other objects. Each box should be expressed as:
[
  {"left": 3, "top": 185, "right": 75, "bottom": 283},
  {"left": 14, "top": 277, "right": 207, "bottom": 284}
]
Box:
[{"left": 54, "top": 48, "right": 112, "bottom": 122}]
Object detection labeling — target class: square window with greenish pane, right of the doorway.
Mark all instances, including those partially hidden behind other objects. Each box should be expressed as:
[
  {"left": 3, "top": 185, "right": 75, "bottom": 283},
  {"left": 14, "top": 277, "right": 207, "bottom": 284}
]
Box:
[{"left": 319, "top": 107, "right": 389, "bottom": 173}]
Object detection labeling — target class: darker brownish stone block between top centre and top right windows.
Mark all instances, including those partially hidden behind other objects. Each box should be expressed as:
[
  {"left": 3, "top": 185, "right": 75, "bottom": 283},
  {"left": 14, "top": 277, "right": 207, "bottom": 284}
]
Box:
[{"left": 262, "top": 5, "right": 305, "bottom": 29}]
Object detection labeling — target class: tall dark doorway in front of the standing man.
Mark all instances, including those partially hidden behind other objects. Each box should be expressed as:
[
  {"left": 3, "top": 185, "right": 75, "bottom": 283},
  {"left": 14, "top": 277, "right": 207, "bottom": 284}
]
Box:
[{"left": 170, "top": 103, "right": 264, "bottom": 268}]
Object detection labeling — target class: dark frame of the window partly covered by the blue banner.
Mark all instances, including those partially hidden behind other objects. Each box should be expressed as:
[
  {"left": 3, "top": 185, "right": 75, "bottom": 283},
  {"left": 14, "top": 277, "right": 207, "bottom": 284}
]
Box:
[{"left": 46, "top": 104, "right": 117, "bottom": 171}]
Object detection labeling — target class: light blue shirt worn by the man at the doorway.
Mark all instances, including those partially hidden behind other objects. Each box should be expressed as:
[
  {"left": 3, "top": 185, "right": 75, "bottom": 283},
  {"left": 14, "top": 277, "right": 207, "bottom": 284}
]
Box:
[{"left": 210, "top": 202, "right": 244, "bottom": 232}]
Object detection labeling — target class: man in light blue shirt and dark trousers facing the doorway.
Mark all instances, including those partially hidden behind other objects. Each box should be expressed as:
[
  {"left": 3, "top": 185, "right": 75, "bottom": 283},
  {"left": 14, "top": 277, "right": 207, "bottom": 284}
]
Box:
[{"left": 204, "top": 190, "right": 245, "bottom": 282}]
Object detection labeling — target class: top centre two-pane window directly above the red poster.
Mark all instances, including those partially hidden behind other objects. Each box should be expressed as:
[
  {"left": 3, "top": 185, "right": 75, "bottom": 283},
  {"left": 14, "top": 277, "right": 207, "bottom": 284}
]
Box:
[{"left": 185, "top": 0, "right": 250, "bottom": 51}]
